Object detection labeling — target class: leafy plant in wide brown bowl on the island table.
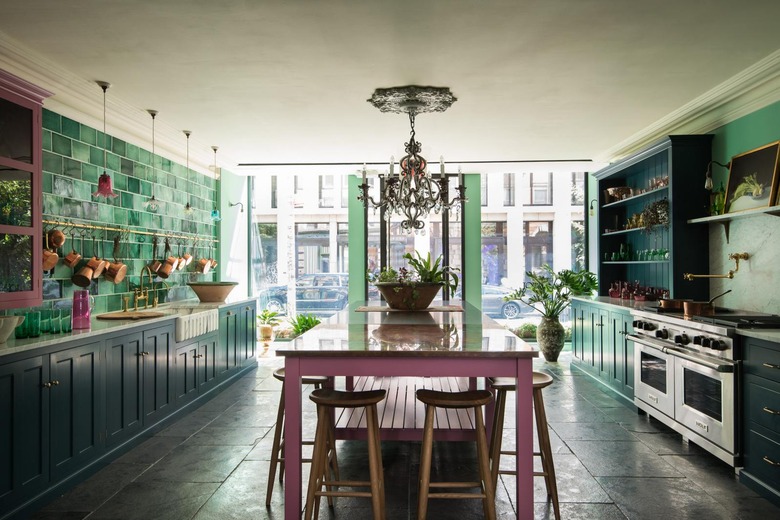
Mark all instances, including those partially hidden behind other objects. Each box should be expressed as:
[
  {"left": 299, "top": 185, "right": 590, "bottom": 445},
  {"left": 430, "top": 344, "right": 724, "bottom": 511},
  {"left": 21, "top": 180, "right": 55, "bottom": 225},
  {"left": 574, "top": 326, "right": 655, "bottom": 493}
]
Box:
[{"left": 368, "top": 251, "right": 459, "bottom": 311}]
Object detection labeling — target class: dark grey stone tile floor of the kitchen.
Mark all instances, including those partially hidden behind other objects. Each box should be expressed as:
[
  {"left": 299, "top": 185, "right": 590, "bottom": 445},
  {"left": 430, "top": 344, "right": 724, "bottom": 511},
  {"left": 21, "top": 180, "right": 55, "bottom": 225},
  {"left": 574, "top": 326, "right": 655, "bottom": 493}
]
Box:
[{"left": 31, "top": 352, "right": 780, "bottom": 520}]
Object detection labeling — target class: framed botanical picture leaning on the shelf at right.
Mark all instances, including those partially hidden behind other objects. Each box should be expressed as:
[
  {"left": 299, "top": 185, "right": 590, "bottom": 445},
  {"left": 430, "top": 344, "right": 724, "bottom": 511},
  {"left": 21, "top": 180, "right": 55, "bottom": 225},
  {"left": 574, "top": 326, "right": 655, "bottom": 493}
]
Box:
[{"left": 726, "top": 141, "right": 780, "bottom": 213}]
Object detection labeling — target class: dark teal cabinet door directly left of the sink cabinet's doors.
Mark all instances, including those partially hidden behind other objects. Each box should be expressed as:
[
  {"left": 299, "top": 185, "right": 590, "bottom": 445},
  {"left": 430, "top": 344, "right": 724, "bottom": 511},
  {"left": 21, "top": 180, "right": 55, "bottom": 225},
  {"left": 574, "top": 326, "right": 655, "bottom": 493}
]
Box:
[{"left": 142, "top": 326, "right": 174, "bottom": 425}]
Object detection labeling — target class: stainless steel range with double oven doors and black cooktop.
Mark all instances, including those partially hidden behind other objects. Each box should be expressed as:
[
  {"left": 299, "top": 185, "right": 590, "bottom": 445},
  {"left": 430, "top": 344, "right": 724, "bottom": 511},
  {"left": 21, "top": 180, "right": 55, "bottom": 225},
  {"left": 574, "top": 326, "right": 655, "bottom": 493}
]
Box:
[{"left": 628, "top": 309, "right": 780, "bottom": 466}]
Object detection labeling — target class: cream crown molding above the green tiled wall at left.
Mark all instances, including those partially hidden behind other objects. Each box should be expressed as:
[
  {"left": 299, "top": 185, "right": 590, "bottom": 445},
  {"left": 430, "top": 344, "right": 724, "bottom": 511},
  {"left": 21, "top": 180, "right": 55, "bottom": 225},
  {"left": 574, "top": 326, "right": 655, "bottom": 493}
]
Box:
[{"left": 0, "top": 32, "right": 222, "bottom": 177}]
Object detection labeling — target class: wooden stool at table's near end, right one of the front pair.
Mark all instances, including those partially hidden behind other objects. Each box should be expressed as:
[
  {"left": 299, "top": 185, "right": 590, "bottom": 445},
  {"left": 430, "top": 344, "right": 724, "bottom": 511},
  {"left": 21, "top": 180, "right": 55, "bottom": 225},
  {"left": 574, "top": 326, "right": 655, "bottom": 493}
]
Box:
[{"left": 417, "top": 390, "right": 496, "bottom": 520}]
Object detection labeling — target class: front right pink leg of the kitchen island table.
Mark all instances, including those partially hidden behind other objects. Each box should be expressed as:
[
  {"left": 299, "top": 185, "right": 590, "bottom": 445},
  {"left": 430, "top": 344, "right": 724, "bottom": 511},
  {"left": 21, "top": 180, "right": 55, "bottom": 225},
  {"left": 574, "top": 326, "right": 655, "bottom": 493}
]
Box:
[{"left": 515, "top": 359, "right": 534, "bottom": 520}]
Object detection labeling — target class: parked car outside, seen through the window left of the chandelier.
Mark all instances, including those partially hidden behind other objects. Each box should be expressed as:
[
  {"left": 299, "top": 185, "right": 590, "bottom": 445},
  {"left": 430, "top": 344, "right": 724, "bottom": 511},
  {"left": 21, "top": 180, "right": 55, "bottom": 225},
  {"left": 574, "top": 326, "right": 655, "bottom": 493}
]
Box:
[{"left": 260, "top": 273, "right": 349, "bottom": 316}]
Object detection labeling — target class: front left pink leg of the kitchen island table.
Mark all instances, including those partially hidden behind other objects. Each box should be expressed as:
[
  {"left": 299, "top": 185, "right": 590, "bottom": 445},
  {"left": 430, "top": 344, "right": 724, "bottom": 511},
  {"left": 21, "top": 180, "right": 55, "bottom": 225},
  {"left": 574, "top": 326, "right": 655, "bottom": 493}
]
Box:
[{"left": 284, "top": 356, "right": 302, "bottom": 518}]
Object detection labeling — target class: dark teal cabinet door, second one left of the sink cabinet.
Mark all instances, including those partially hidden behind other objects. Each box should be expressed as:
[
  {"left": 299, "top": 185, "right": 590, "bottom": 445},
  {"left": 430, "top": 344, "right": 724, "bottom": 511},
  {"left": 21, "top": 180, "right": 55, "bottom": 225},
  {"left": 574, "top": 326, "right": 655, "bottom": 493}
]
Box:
[{"left": 106, "top": 332, "right": 143, "bottom": 446}]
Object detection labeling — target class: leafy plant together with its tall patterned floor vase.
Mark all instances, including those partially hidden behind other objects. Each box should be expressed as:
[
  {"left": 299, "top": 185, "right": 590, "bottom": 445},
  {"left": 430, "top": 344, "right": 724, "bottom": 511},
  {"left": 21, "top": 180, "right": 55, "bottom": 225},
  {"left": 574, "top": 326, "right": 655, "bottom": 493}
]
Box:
[{"left": 504, "top": 264, "right": 598, "bottom": 362}]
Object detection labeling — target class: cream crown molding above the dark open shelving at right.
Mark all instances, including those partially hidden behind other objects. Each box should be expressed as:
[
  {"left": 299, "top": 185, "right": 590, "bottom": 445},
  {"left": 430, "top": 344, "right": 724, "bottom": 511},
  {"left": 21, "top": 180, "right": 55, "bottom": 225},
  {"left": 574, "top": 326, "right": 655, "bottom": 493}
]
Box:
[{"left": 594, "top": 50, "right": 780, "bottom": 162}]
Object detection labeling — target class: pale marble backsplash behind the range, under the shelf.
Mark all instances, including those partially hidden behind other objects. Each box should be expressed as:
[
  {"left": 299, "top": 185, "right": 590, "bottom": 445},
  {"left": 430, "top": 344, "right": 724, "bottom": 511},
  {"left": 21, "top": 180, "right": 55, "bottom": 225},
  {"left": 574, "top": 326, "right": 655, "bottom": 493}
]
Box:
[{"left": 708, "top": 211, "right": 780, "bottom": 314}]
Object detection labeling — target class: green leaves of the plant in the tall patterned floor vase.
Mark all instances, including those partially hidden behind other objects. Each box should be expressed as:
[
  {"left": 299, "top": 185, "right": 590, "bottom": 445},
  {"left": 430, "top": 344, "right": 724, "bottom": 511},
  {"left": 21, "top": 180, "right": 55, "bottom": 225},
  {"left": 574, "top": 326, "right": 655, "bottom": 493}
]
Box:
[{"left": 504, "top": 264, "right": 598, "bottom": 318}]
